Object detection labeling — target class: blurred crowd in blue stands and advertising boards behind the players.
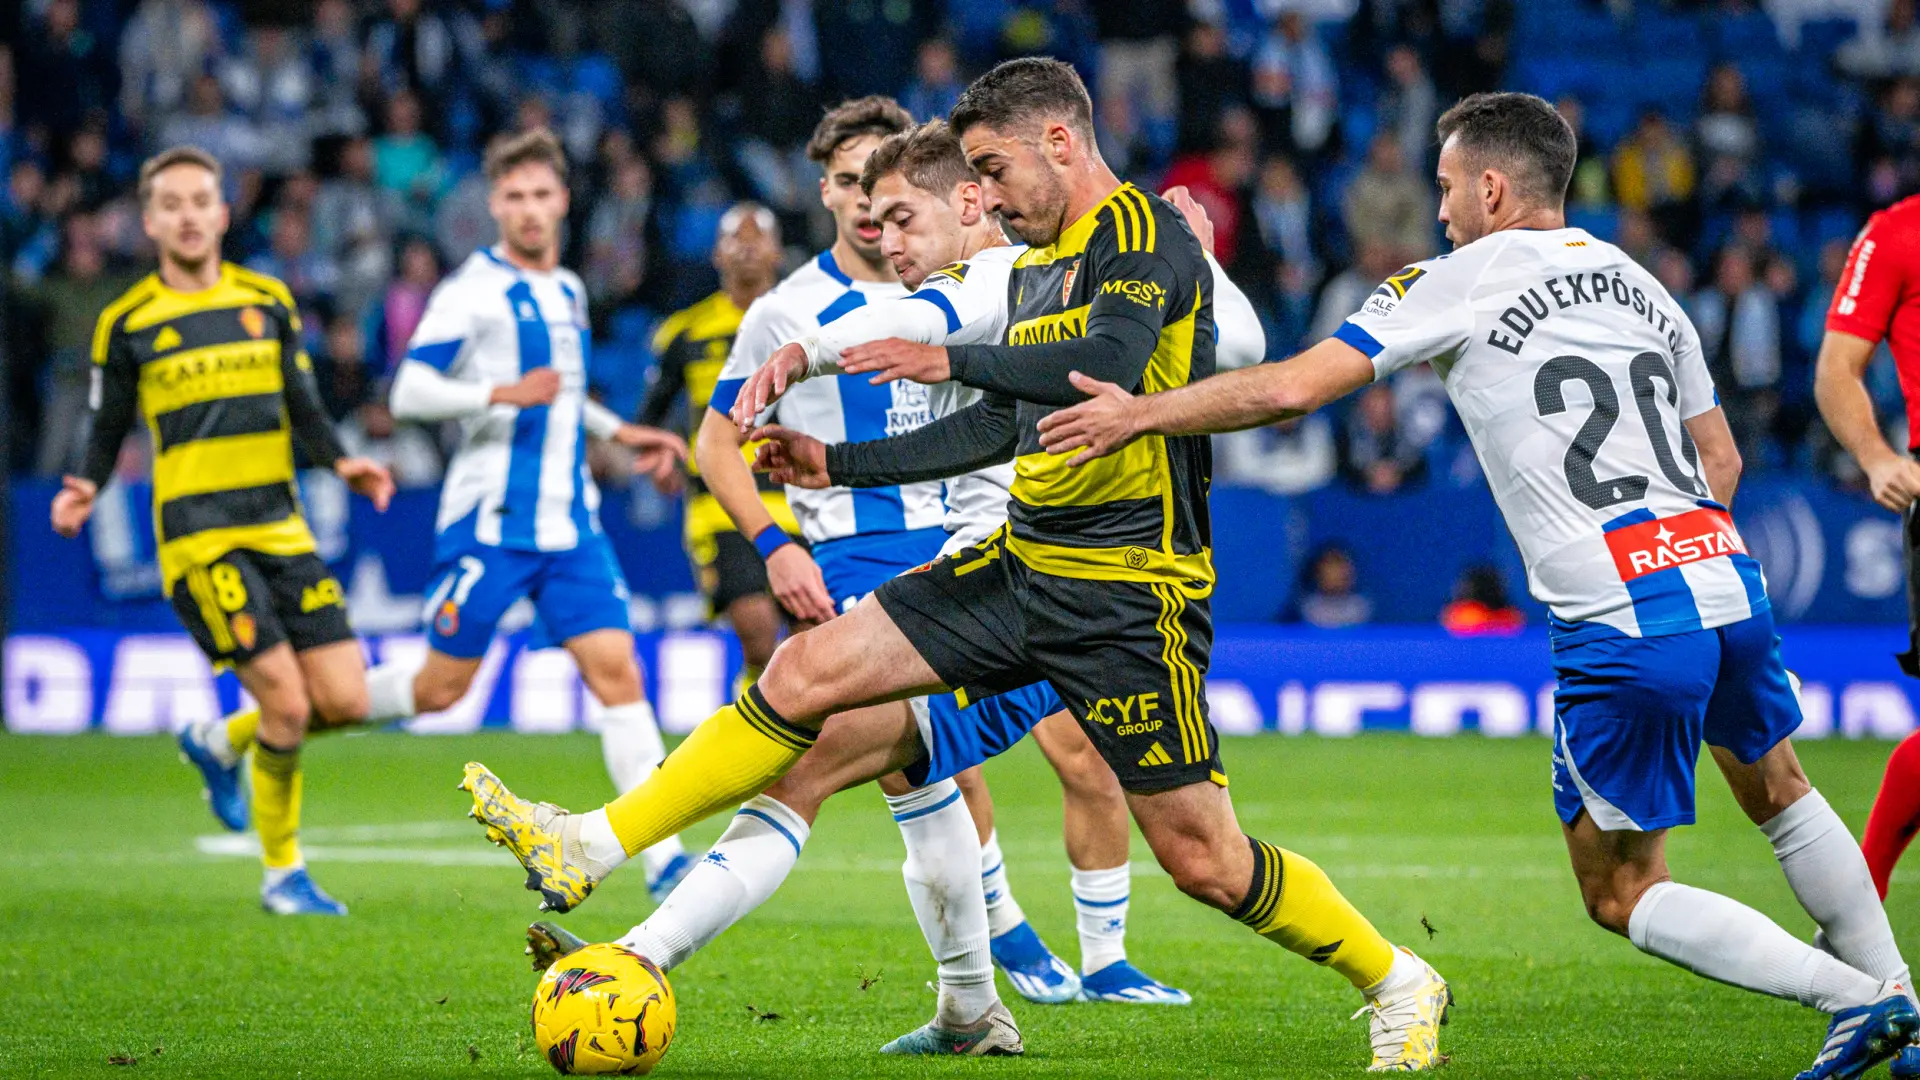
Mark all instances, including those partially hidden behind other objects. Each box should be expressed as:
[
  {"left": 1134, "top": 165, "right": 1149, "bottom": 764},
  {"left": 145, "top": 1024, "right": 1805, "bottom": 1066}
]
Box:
[{"left": 0, "top": 0, "right": 1920, "bottom": 736}]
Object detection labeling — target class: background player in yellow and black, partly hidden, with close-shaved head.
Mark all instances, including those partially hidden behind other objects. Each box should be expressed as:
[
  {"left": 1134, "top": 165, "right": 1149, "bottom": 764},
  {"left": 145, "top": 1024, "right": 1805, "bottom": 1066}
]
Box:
[{"left": 639, "top": 202, "right": 801, "bottom": 684}]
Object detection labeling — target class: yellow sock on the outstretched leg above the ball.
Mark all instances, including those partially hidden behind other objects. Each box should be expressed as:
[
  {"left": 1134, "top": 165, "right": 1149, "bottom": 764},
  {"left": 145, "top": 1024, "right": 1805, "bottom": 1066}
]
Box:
[{"left": 607, "top": 686, "right": 820, "bottom": 855}]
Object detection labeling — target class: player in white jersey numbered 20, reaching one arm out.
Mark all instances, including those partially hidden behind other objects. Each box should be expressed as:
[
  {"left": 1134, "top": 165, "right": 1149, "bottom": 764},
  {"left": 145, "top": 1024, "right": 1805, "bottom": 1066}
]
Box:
[{"left": 1041, "top": 94, "right": 1920, "bottom": 1080}]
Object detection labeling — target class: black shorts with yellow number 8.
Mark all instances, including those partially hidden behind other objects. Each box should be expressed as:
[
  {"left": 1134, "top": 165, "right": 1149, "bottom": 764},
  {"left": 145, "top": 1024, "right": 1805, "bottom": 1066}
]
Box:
[{"left": 173, "top": 550, "right": 353, "bottom": 665}]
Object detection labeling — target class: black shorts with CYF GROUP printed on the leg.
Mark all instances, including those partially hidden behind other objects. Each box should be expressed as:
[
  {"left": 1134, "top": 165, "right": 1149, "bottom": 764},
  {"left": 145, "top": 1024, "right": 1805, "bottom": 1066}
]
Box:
[{"left": 874, "top": 530, "right": 1227, "bottom": 792}]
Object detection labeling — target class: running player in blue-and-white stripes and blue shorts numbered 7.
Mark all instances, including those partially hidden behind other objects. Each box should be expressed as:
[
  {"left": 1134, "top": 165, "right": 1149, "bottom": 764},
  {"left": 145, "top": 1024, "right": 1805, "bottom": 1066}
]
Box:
[{"left": 369, "top": 131, "right": 689, "bottom": 896}]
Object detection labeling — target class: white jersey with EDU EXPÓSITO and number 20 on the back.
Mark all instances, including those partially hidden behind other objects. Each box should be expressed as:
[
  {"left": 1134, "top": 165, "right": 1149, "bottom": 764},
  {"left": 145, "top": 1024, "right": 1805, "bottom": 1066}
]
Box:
[{"left": 1334, "top": 229, "right": 1766, "bottom": 642}]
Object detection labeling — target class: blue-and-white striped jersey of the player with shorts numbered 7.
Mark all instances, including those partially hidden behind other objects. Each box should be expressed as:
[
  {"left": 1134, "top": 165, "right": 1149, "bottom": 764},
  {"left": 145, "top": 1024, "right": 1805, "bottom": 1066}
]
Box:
[{"left": 396, "top": 248, "right": 599, "bottom": 552}]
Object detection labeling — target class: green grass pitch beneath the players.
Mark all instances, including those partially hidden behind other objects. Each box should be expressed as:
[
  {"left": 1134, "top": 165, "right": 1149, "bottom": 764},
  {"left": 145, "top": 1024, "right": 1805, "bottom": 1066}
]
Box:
[{"left": 0, "top": 734, "right": 1920, "bottom": 1080}]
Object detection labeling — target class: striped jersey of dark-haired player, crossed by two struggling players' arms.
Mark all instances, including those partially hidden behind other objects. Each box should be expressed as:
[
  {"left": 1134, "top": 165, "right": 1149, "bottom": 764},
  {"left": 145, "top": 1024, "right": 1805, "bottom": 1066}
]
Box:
[{"left": 707, "top": 252, "right": 947, "bottom": 544}]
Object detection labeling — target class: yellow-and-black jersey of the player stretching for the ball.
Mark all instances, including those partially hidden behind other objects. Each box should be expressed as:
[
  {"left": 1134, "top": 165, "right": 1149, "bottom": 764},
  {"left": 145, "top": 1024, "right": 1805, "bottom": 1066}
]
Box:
[{"left": 828, "top": 184, "right": 1215, "bottom": 586}]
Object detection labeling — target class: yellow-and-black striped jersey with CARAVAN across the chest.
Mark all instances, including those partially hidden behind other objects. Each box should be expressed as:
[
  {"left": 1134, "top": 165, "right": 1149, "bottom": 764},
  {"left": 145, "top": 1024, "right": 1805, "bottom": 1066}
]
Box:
[{"left": 81, "top": 263, "right": 344, "bottom": 590}]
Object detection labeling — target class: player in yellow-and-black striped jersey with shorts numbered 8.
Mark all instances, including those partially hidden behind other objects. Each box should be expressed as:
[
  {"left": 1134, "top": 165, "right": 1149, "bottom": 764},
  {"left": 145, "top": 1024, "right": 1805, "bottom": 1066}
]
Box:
[{"left": 52, "top": 146, "right": 394, "bottom": 915}]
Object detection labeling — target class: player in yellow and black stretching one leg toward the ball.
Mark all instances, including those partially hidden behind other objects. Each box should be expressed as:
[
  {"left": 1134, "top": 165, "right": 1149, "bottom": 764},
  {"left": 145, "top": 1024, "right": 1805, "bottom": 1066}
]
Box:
[{"left": 465, "top": 60, "right": 1452, "bottom": 1070}]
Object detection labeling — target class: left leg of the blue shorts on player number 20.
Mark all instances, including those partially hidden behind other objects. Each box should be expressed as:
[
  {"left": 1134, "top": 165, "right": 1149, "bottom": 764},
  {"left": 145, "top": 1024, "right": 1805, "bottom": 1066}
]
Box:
[{"left": 1553, "top": 630, "right": 1720, "bottom": 830}]
